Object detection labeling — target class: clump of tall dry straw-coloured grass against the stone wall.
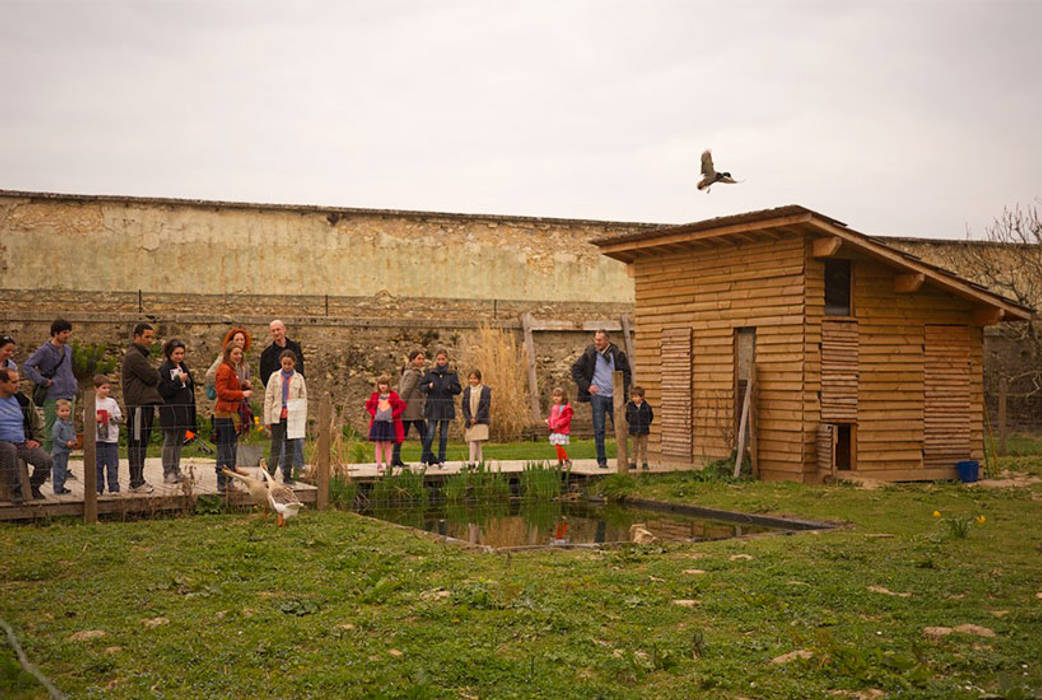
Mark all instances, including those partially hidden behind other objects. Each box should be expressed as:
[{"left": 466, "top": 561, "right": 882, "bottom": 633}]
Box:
[{"left": 458, "top": 324, "right": 531, "bottom": 443}]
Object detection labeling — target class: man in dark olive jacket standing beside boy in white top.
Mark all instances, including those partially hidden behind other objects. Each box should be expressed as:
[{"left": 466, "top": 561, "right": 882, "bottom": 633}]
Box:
[{"left": 123, "top": 323, "right": 163, "bottom": 494}]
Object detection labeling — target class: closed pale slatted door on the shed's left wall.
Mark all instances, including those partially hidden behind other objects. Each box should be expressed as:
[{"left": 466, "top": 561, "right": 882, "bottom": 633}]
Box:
[{"left": 656, "top": 328, "right": 695, "bottom": 461}]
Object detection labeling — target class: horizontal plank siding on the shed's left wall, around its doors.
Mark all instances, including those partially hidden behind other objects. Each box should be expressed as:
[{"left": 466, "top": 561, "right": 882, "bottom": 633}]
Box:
[{"left": 634, "top": 235, "right": 805, "bottom": 479}]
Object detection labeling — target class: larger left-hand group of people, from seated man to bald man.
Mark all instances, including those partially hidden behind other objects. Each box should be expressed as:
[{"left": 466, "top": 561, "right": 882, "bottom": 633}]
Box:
[{"left": 0, "top": 319, "right": 307, "bottom": 501}]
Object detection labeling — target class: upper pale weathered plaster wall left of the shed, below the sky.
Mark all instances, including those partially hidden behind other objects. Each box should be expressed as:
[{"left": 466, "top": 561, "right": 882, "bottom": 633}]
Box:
[{"left": 0, "top": 191, "right": 651, "bottom": 303}]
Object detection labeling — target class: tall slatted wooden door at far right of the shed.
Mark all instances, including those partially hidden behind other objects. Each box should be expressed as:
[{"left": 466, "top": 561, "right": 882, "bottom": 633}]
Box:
[{"left": 922, "top": 325, "right": 970, "bottom": 469}]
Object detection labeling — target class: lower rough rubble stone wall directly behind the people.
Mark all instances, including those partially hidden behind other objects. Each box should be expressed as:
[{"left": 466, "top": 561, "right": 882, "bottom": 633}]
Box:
[{"left": 0, "top": 291, "right": 632, "bottom": 433}]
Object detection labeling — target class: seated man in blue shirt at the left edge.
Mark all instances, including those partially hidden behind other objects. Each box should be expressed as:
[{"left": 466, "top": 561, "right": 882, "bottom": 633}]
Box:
[{"left": 0, "top": 367, "right": 51, "bottom": 502}]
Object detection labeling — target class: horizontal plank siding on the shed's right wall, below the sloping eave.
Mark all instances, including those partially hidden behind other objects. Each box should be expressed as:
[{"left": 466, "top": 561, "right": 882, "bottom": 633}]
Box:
[{"left": 803, "top": 251, "right": 983, "bottom": 480}]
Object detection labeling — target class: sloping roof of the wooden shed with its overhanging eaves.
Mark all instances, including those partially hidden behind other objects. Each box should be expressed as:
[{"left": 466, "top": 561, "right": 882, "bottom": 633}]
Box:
[{"left": 591, "top": 205, "right": 1035, "bottom": 325}]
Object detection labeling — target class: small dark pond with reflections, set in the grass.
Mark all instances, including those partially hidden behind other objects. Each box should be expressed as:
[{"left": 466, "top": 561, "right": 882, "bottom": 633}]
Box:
[{"left": 362, "top": 501, "right": 807, "bottom": 549}]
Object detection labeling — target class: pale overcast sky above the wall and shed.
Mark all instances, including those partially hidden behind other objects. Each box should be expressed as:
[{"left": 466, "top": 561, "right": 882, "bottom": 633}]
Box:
[{"left": 0, "top": 0, "right": 1042, "bottom": 238}]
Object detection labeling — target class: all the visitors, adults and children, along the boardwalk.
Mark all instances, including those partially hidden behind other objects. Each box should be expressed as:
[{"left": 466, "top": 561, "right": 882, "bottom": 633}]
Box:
[{"left": 0, "top": 319, "right": 653, "bottom": 500}]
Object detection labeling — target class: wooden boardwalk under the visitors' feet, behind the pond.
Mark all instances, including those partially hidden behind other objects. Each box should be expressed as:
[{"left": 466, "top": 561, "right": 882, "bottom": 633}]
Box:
[{"left": 0, "top": 457, "right": 672, "bottom": 521}]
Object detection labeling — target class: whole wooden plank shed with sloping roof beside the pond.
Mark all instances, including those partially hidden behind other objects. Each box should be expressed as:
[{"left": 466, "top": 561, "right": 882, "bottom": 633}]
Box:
[{"left": 593, "top": 205, "right": 1033, "bottom": 481}]
